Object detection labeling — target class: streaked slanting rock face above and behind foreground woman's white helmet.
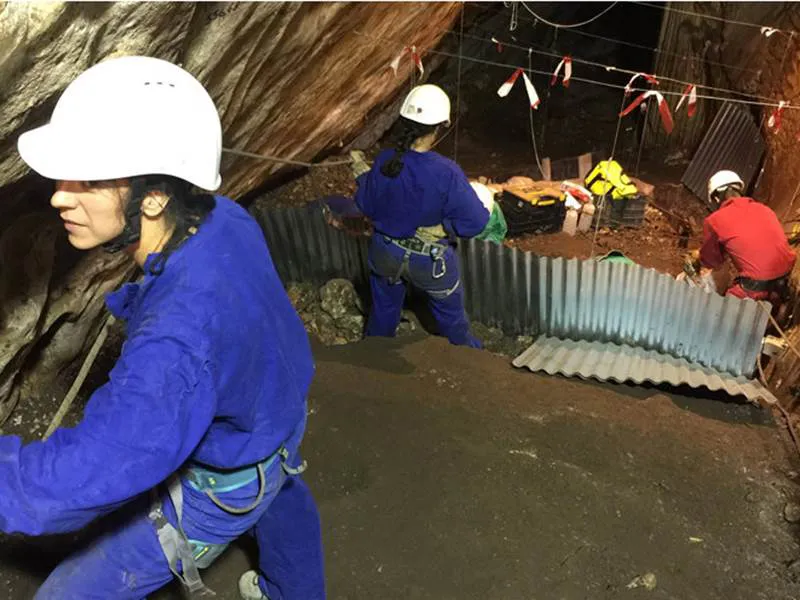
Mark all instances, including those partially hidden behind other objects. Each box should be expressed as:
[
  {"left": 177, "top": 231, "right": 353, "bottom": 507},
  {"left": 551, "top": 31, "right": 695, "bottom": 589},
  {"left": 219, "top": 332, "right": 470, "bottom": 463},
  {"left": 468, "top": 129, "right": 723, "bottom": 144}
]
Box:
[{"left": 0, "top": 2, "right": 459, "bottom": 197}]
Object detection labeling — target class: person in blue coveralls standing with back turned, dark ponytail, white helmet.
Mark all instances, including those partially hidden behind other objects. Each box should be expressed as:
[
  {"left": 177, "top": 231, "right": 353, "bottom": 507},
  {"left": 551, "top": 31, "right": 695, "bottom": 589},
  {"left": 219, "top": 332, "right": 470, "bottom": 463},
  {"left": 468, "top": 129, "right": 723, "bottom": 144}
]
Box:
[{"left": 355, "top": 84, "right": 490, "bottom": 348}]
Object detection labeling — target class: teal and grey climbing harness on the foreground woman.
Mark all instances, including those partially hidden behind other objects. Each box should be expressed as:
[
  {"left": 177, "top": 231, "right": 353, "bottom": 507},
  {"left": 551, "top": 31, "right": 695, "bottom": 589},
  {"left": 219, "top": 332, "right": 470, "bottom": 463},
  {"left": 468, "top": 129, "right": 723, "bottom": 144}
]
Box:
[{"left": 148, "top": 438, "right": 308, "bottom": 598}]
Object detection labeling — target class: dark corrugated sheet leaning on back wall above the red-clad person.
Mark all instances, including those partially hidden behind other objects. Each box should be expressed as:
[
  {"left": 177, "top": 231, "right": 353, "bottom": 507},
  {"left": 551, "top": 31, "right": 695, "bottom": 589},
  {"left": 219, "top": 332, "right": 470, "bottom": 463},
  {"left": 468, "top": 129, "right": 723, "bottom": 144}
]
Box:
[{"left": 681, "top": 103, "right": 765, "bottom": 201}]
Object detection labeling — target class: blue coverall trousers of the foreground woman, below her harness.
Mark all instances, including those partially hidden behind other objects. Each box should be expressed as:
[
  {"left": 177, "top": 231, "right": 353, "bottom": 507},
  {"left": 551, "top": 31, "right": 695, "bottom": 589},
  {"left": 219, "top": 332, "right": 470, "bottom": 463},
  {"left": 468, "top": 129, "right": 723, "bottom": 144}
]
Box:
[{"left": 35, "top": 422, "right": 325, "bottom": 600}]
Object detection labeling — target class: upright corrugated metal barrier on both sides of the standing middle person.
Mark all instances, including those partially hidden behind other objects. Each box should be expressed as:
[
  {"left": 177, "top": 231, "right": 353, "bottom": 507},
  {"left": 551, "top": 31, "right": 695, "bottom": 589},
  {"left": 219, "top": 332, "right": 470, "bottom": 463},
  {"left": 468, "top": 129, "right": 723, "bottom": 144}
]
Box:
[{"left": 256, "top": 205, "right": 767, "bottom": 376}]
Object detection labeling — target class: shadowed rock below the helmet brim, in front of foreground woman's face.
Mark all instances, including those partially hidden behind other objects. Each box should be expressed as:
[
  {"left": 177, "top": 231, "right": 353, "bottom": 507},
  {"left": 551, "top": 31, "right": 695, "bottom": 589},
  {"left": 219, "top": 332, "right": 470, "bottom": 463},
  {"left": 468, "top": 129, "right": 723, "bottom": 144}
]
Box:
[{"left": 0, "top": 212, "right": 134, "bottom": 423}]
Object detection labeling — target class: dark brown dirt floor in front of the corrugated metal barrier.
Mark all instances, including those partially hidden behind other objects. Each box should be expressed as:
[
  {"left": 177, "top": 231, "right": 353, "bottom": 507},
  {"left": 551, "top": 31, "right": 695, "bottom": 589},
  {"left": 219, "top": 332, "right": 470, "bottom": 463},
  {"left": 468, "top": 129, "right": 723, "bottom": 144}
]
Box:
[{"left": 0, "top": 336, "right": 800, "bottom": 600}]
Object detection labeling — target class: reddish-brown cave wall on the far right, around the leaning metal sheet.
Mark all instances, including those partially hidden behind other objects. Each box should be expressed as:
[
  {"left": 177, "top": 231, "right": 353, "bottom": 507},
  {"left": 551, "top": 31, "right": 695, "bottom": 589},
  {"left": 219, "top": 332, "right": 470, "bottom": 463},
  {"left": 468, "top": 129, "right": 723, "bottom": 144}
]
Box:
[{"left": 650, "top": 2, "right": 800, "bottom": 418}]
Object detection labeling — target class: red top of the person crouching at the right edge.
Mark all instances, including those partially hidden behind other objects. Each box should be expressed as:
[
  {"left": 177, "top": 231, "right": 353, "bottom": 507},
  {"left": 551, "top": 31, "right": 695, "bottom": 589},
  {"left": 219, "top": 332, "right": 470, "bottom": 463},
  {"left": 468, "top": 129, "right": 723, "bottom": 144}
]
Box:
[{"left": 700, "top": 197, "right": 797, "bottom": 280}]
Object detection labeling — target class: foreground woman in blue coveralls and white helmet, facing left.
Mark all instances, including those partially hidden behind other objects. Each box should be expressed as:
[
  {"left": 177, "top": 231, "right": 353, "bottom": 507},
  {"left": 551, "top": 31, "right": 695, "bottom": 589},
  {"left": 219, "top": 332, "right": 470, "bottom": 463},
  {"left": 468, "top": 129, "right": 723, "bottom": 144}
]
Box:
[{"left": 0, "top": 56, "right": 325, "bottom": 600}]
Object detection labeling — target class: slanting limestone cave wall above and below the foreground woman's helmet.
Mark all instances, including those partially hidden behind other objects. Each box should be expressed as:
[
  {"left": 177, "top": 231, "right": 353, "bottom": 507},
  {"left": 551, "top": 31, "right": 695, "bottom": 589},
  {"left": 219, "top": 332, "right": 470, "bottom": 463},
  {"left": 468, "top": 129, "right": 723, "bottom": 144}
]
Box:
[{"left": 0, "top": 2, "right": 460, "bottom": 424}]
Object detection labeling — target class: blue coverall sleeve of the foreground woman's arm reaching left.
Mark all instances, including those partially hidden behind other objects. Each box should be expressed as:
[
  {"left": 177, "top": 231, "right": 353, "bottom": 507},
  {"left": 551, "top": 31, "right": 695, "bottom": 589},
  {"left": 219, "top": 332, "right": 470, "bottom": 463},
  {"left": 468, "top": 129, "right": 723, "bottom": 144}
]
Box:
[{"left": 0, "top": 318, "right": 216, "bottom": 535}]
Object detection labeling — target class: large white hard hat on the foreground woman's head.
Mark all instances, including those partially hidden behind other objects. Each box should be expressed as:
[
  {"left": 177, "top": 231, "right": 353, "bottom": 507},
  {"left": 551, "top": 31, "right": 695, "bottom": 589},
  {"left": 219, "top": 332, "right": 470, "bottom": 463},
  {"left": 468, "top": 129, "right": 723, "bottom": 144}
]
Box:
[{"left": 17, "top": 56, "right": 222, "bottom": 191}]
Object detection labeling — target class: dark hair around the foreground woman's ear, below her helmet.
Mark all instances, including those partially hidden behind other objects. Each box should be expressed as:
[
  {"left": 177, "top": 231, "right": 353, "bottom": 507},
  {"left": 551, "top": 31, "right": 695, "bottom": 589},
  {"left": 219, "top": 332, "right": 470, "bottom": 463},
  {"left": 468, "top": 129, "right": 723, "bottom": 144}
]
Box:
[{"left": 104, "top": 175, "right": 216, "bottom": 275}]
